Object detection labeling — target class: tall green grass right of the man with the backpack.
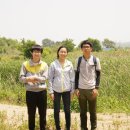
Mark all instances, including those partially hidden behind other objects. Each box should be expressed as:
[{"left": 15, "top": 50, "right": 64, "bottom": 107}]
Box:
[{"left": 98, "top": 50, "right": 130, "bottom": 112}]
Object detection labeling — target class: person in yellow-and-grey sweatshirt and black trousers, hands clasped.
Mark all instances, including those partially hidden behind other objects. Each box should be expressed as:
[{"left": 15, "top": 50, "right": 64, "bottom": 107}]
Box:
[{"left": 20, "top": 45, "right": 48, "bottom": 130}]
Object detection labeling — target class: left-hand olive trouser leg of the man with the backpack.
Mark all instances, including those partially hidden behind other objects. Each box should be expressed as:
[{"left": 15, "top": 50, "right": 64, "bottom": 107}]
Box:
[{"left": 79, "top": 89, "right": 88, "bottom": 130}]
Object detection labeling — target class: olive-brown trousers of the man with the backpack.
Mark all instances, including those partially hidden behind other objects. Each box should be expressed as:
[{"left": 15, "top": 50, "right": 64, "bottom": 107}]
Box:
[{"left": 79, "top": 89, "right": 97, "bottom": 130}]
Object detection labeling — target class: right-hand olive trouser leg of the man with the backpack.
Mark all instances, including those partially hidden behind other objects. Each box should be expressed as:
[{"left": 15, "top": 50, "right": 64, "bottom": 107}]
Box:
[{"left": 88, "top": 98, "right": 97, "bottom": 130}]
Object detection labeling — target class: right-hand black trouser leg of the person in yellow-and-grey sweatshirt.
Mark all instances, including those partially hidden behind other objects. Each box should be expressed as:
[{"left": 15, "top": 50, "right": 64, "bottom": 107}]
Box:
[{"left": 37, "top": 90, "right": 47, "bottom": 130}]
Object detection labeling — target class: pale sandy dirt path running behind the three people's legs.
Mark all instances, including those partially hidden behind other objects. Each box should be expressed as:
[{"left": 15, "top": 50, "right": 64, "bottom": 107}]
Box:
[{"left": 0, "top": 104, "right": 130, "bottom": 130}]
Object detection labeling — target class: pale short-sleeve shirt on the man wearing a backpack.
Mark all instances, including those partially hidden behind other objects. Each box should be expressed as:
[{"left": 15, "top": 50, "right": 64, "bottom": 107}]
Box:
[{"left": 79, "top": 55, "right": 101, "bottom": 89}]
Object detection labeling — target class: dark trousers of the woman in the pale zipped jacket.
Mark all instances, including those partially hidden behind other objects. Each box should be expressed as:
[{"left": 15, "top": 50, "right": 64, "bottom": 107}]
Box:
[{"left": 54, "top": 92, "right": 71, "bottom": 130}]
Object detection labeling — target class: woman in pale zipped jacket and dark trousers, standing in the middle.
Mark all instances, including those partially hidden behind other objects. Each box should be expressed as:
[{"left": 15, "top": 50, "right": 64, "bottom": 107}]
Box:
[{"left": 49, "top": 46, "right": 74, "bottom": 130}]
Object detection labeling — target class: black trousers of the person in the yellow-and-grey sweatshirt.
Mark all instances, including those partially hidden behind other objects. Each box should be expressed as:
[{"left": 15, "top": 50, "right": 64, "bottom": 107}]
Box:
[{"left": 26, "top": 90, "right": 47, "bottom": 130}]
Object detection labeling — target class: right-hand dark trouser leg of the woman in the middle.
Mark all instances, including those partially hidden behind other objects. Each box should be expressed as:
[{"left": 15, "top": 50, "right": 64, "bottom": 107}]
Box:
[{"left": 62, "top": 92, "right": 71, "bottom": 130}]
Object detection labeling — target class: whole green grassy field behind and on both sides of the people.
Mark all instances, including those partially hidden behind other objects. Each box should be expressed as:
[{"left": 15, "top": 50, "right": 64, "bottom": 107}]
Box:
[{"left": 0, "top": 49, "right": 130, "bottom": 113}]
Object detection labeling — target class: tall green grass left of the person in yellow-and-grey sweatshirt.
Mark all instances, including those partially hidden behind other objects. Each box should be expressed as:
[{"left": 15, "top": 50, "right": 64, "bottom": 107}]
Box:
[{"left": 0, "top": 60, "right": 25, "bottom": 104}]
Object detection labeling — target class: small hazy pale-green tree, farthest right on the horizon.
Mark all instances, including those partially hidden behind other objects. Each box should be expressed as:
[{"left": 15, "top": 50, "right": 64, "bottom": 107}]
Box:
[{"left": 102, "top": 38, "right": 116, "bottom": 48}]
